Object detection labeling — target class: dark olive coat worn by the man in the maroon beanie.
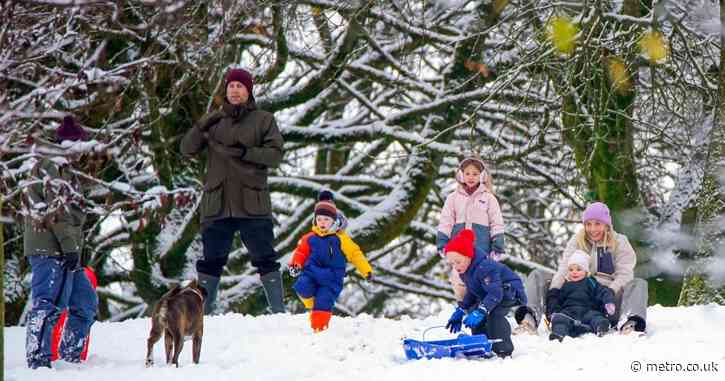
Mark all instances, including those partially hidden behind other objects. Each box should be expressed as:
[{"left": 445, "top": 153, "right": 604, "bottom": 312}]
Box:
[{"left": 181, "top": 103, "right": 283, "bottom": 224}]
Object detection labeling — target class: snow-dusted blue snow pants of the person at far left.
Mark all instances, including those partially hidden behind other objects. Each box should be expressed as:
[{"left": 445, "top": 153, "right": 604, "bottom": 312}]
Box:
[{"left": 25, "top": 255, "right": 98, "bottom": 368}]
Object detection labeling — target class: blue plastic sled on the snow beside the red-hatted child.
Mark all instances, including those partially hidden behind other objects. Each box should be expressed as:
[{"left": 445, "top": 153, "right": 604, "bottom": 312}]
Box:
[{"left": 403, "top": 334, "right": 494, "bottom": 360}]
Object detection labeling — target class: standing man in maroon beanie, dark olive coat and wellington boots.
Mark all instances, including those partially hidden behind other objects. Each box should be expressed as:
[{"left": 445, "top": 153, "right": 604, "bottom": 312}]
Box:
[{"left": 181, "top": 69, "right": 285, "bottom": 314}]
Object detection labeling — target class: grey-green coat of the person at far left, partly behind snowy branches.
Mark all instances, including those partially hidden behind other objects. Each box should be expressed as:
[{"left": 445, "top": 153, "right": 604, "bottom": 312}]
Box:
[{"left": 23, "top": 159, "right": 86, "bottom": 256}]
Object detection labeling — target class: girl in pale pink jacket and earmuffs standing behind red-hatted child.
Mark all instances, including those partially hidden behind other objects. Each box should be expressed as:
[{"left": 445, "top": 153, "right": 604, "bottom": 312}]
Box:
[{"left": 436, "top": 157, "right": 504, "bottom": 300}]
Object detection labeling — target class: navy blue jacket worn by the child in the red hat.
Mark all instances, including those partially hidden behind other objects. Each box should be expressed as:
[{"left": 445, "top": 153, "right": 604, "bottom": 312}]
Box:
[{"left": 458, "top": 255, "right": 527, "bottom": 312}]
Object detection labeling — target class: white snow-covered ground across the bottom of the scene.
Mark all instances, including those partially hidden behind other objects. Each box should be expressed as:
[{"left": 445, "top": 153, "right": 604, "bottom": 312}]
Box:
[{"left": 5, "top": 305, "right": 725, "bottom": 381}]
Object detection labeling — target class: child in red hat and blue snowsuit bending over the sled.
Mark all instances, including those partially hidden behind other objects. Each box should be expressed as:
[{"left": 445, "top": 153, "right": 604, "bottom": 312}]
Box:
[{"left": 444, "top": 229, "right": 527, "bottom": 357}]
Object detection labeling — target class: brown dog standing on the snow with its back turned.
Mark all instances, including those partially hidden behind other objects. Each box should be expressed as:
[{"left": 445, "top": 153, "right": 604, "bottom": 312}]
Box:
[{"left": 146, "top": 280, "right": 206, "bottom": 368}]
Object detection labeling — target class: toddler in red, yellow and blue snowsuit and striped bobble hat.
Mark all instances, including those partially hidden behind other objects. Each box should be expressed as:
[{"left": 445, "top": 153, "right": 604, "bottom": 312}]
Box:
[{"left": 289, "top": 191, "right": 372, "bottom": 332}]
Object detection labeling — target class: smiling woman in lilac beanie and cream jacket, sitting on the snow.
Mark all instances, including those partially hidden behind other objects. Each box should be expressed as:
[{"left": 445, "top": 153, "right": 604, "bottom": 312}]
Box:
[{"left": 515, "top": 202, "right": 648, "bottom": 334}]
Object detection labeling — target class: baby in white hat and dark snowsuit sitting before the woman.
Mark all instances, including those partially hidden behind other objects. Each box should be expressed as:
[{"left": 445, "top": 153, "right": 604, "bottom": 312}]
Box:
[{"left": 546, "top": 250, "right": 615, "bottom": 341}]
